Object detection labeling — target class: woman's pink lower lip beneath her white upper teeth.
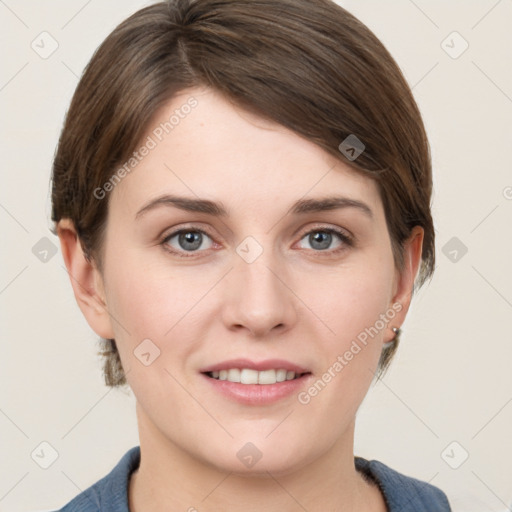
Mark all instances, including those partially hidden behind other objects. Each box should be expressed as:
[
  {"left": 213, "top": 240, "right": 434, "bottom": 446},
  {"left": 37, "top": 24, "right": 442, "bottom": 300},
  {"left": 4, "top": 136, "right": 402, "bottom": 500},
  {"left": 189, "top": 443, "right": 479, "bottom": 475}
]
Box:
[{"left": 201, "top": 373, "right": 311, "bottom": 405}]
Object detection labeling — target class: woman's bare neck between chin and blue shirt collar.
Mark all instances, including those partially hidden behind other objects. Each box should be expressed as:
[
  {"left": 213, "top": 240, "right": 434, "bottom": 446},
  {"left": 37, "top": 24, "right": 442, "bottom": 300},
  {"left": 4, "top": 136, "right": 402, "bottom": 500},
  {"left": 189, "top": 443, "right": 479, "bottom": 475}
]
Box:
[{"left": 129, "top": 407, "right": 386, "bottom": 512}]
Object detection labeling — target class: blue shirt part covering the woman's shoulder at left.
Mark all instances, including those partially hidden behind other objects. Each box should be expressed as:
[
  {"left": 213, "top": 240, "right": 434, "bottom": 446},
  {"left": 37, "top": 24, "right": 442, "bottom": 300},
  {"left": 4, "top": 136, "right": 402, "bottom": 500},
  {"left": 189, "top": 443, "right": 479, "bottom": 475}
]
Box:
[{"left": 55, "top": 446, "right": 140, "bottom": 512}]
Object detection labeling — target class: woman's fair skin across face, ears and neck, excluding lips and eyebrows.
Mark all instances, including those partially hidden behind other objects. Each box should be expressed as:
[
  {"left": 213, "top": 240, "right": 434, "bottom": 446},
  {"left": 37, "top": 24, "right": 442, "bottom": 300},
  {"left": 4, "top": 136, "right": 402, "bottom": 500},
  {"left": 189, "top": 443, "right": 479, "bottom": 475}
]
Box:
[{"left": 58, "top": 88, "right": 423, "bottom": 512}]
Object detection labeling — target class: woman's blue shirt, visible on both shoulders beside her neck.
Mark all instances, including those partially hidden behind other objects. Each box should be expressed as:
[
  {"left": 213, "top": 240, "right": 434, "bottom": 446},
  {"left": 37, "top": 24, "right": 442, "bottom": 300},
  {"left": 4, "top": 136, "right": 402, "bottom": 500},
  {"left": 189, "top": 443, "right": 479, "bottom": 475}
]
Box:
[{"left": 56, "top": 446, "right": 451, "bottom": 512}]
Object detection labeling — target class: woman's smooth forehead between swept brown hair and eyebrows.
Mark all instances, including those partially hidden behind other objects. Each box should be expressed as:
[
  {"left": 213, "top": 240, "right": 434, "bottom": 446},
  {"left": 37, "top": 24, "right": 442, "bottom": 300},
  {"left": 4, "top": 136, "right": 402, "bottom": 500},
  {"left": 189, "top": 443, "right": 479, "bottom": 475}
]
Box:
[{"left": 109, "top": 88, "right": 382, "bottom": 222}]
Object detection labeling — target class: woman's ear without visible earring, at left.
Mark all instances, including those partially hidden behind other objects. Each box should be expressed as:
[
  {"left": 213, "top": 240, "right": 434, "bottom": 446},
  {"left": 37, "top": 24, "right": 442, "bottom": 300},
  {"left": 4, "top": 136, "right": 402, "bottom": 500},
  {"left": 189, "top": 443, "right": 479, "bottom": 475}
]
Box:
[{"left": 57, "top": 219, "right": 114, "bottom": 339}]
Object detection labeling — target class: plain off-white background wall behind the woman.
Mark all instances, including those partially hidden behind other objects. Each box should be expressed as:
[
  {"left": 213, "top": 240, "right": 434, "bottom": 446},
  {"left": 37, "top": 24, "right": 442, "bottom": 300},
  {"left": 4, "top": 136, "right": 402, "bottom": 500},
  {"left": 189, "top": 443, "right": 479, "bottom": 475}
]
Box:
[{"left": 0, "top": 0, "right": 512, "bottom": 512}]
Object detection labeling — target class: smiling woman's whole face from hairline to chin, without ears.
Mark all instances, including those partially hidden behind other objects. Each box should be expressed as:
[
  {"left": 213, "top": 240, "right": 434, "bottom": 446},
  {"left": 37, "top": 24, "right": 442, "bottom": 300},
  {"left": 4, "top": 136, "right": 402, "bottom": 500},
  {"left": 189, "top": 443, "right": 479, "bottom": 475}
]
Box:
[{"left": 89, "top": 89, "right": 412, "bottom": 474}]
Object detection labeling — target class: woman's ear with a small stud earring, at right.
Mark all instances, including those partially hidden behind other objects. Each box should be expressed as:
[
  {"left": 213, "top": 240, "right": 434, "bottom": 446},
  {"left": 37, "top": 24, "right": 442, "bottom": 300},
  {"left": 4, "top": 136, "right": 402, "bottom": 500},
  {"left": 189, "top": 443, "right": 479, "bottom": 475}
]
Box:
[{"left": 384, "top": 226, "right": 425, "bottom": 342}]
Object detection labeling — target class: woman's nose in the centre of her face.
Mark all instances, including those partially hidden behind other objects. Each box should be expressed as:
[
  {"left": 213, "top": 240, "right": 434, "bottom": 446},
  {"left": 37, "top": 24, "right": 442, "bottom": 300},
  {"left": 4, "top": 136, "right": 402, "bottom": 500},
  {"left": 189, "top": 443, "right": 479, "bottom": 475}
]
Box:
[{"left": 222, "top": 245, "right": 297, "bottom": 339}]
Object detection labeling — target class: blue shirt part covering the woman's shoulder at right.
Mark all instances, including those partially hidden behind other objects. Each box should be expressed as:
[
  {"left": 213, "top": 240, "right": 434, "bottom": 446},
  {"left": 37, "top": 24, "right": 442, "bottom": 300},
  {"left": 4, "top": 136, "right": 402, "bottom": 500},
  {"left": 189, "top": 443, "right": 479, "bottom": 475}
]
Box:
[{"left": 355, "top": 457, "right": 451, "bottom": 512}]
